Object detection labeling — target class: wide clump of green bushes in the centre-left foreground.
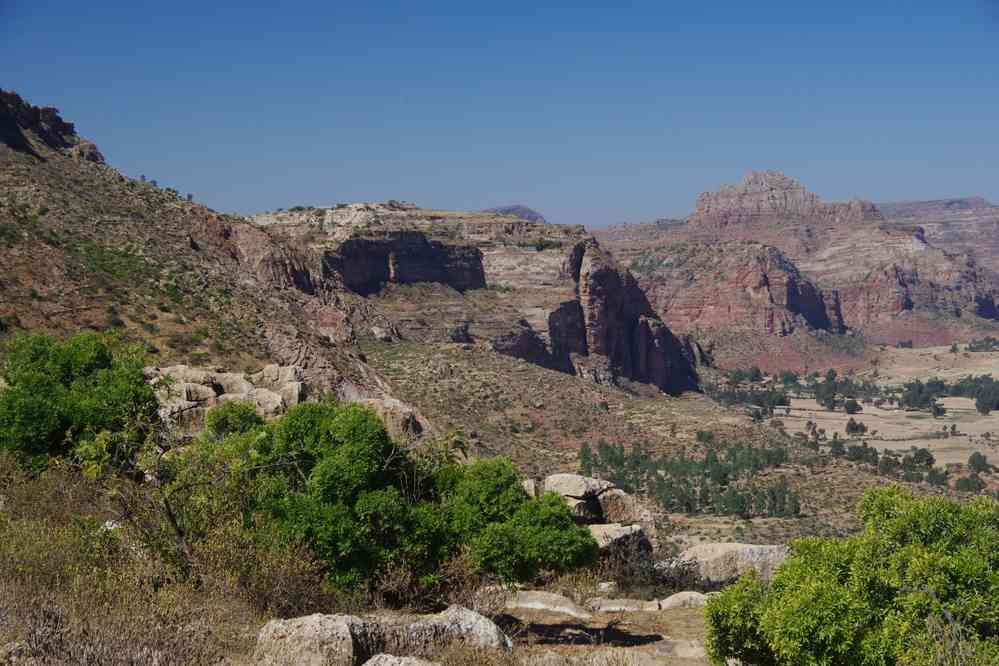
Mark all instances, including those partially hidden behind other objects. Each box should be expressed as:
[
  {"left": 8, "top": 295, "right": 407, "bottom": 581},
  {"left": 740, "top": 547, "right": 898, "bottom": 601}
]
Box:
[{"left": 164, "top": 402, "right": 596, "bottom": 594}]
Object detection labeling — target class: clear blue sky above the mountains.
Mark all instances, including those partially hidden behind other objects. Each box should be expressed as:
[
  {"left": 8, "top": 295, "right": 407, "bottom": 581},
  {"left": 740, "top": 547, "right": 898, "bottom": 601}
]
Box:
[{"left": 0, "top": 0, "right": 999, "bottom": 225}]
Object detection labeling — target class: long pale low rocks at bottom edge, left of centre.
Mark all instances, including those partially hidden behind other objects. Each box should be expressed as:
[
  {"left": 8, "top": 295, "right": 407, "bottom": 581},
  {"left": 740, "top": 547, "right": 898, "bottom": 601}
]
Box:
[{"left": 253, "top": 606, "right": 512, "bottom": 666}]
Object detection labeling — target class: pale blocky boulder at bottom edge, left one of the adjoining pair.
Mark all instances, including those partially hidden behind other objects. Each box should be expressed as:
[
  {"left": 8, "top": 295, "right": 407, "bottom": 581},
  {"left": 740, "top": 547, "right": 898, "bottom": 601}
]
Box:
[{"left": 253, "top": 613, "right": 385, "bottom": 666}]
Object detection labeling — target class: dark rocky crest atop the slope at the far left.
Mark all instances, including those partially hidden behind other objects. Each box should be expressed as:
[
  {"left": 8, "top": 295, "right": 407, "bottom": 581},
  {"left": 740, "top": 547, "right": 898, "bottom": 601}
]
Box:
[{"left": 0, "top": 90, "right": 104, "bottom": 164}]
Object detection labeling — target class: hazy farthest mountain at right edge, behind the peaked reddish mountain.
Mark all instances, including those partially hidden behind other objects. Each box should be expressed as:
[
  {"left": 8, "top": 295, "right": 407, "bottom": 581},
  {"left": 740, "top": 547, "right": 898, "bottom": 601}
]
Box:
[{"left": 878, "top": 197, "right": 999, "bottom": 271}]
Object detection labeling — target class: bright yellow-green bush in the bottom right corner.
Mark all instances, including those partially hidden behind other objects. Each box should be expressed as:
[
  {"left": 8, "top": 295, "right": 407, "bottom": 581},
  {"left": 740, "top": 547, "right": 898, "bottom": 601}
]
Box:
[{"left": 706, "top": 486, "right": 999, "bottom": 666}]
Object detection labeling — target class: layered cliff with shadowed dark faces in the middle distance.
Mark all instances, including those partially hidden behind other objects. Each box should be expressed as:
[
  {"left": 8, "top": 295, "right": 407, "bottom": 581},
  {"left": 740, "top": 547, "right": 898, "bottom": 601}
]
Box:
[{"left": 255, "top": 202, "right": 697, "bottom": 393}]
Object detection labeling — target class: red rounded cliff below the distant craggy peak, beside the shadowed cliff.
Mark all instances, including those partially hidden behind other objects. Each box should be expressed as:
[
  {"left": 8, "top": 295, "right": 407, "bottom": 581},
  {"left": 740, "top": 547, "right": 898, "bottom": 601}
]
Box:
[{"left": 632, "top": 241, "right": 845, "bottom": 336}]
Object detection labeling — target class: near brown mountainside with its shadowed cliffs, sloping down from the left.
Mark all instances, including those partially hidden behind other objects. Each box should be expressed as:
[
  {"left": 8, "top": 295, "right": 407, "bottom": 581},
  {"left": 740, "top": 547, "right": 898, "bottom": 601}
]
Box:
[{"left": 0, "top": 92, "right": 714, "bottom": 472}]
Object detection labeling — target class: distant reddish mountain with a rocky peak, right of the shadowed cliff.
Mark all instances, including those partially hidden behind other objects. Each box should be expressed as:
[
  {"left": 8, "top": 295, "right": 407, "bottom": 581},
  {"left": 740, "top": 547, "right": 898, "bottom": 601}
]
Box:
[{"left": 597, "top": 171, "right": 999, "bottom": 363}]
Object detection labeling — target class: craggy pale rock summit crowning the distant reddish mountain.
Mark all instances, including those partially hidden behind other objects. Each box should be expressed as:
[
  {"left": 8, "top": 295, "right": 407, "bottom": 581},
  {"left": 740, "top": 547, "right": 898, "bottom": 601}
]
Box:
[{"left": 690, "top": 171, "right": 883, "bottom": 226}]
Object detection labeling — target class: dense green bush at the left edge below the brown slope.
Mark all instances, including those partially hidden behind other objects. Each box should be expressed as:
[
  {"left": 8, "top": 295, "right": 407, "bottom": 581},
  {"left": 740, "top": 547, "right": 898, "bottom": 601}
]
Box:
[{"left": 0, "top": 333, "right": 157, "bottom": 471}]
